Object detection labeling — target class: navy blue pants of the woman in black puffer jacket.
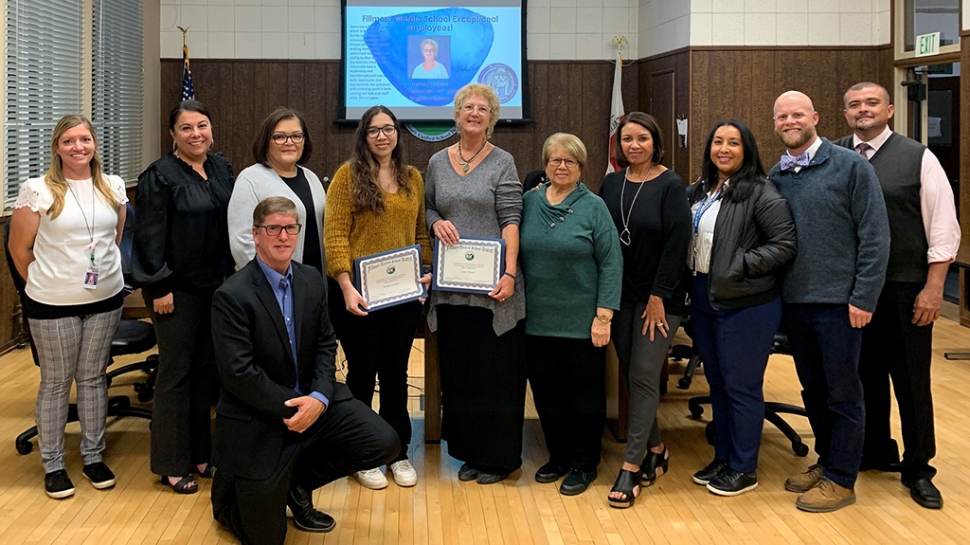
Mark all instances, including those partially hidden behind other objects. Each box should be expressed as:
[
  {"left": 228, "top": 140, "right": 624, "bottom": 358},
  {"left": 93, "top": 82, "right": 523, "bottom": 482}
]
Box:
[{"left": 690, "top": 274, "right": 781, "bottom": 473}]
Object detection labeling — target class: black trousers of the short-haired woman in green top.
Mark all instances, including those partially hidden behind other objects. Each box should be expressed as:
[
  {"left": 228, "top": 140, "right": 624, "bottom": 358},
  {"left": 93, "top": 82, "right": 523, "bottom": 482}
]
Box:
[{"left": 525, "top": 335, "right": 606, "bottom": 471}]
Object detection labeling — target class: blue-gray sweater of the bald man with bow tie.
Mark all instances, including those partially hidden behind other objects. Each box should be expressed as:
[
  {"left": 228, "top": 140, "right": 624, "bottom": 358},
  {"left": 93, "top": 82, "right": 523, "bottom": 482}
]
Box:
[{"left": 768, "top": 138, "right": 889, "bottom": 312}]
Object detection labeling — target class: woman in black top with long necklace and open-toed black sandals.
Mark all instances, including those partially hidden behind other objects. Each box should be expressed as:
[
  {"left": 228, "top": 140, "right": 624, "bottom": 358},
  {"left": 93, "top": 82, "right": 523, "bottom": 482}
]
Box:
[{"left": 600, "top": 112, "right": 690, "bottom": 508}]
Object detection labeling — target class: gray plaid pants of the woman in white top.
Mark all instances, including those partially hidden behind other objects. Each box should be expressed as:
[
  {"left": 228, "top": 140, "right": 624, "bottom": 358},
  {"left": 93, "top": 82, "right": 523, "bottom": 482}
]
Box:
[{"left": 30, "top": 308, "right": 121, "bottom": 473}]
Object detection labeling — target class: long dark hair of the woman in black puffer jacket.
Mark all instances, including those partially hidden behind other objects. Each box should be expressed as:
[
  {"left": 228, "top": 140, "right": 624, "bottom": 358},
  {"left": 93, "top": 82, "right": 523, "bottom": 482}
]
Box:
[{"left": 690, "top": 119, "right": 768, "bottom": 203}]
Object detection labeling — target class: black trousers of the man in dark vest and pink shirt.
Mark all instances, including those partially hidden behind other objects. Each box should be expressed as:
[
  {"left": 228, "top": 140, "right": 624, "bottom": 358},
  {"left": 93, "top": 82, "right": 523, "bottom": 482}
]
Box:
[{"left": 859, "top": 282, "right": 936, "bottom": 478}]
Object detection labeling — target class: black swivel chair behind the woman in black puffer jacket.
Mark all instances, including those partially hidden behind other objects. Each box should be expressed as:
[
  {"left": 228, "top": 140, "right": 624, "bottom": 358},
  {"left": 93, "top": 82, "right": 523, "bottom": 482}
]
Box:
[{"left": 670, "top": 321, "right": 808, "bottom": 456}]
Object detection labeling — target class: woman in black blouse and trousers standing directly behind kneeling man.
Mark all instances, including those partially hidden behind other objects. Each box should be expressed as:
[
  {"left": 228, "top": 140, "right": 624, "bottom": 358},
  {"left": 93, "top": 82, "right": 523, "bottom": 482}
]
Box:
[{"left": 132, "top": 100, "right": 233, "bottom": 494}]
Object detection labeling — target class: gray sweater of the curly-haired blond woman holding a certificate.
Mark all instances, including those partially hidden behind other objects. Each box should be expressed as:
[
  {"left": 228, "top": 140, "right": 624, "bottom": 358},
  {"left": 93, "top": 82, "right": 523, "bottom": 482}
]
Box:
[{"left": 422, "top": 147, "right": 525, "bottom": 335}]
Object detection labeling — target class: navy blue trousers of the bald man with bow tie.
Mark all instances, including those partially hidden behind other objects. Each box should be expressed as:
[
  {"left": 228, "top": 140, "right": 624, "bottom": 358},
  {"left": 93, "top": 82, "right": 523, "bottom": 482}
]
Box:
[{"left": 784, "top": 304, "right": 865, "bottom": 488}]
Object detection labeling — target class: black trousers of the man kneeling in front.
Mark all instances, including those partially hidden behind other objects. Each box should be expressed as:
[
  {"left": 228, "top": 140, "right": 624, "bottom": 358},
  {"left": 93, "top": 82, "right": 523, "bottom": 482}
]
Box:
[{"left": 212, "top": 399, "right": 401, "bottom": 545}]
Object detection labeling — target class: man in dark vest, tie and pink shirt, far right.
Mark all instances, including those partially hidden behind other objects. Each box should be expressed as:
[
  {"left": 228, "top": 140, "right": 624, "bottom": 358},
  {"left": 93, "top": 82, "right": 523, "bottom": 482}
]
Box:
[{"left": 836, "top": 82, "right": 960, "bottom": 509}]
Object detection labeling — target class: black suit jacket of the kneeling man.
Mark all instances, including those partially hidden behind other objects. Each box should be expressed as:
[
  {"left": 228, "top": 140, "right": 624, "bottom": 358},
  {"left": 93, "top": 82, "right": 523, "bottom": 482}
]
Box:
[{"left": 212, "top": 259, "right": 352, "bottom": 480}]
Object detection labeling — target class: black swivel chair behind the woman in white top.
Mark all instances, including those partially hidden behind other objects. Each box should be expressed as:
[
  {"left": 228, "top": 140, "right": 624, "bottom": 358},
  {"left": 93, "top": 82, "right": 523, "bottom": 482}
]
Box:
[{"left": 3, "top": 204, "right": 158, "bottom": 454}]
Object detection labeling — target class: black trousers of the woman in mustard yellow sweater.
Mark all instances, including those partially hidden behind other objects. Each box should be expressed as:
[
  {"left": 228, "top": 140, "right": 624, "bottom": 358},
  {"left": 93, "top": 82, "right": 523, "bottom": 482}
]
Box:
[{"left": 327, "top": 279, "right": 421, "bottom": 462}]
